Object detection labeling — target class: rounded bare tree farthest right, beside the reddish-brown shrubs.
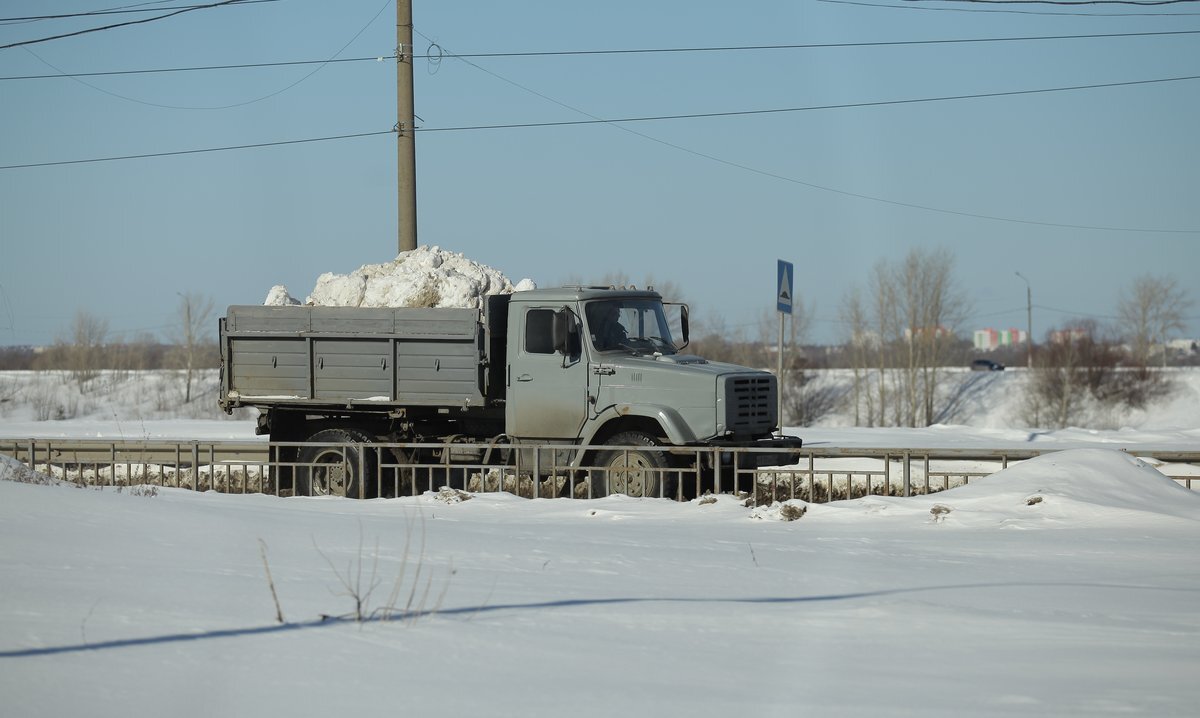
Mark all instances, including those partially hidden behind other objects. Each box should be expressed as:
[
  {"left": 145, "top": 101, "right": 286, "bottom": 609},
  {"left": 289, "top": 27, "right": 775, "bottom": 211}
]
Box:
[{"left": 1117, "top": 274, "right": 1193, "bottom": 366}]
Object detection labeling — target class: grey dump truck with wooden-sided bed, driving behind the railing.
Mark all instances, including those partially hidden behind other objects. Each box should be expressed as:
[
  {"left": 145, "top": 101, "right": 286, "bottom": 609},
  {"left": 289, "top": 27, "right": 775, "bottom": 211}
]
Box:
[{"left": 220, "top": 287, "right": 800, "bottom": 496}]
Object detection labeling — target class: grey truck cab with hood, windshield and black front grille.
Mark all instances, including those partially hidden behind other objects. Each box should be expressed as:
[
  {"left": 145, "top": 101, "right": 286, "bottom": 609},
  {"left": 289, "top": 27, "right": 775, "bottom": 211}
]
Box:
[{"left": 505, "top": 287, "right": 798, "bottom": 468}]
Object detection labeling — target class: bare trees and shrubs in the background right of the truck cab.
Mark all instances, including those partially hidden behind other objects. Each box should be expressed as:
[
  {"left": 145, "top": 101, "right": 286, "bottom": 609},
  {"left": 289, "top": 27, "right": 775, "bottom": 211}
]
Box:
[{"left": 695, "top": 249, "right": 1200, "bottom": 427}]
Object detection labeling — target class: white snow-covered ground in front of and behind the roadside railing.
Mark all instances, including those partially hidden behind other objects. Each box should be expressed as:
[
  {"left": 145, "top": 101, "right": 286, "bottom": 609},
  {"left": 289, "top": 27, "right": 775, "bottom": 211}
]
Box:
[{"left": 0, "top": 372, "right": 1200, "bottom": 717}]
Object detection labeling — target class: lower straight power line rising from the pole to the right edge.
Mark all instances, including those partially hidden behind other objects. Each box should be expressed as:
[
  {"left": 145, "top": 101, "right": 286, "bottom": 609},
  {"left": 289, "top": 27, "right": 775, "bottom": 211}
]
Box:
[{"left": 416, "top": 74, "right": 1200, "bottom": 132}]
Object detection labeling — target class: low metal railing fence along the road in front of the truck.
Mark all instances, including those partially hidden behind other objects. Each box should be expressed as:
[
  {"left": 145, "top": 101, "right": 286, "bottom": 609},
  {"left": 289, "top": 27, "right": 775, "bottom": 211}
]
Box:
[{"left": 0, "top": 439, "right": 1200, "bottom": 504}]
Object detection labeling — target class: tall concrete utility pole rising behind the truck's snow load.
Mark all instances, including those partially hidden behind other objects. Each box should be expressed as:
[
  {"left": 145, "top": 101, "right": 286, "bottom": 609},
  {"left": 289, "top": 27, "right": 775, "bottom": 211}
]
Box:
[{"left": 396, "top": 0, "right": 416, "bottom": 252}]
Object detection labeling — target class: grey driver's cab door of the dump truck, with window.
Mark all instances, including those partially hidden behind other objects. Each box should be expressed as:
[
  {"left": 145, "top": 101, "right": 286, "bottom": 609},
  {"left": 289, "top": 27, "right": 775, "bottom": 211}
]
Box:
[{"left": 505, "top": 305, "right": 588, "bottom": 438}]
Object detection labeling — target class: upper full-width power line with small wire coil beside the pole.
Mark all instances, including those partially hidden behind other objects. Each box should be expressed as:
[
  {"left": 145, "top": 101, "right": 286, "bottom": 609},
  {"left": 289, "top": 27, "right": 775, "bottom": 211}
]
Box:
[{"left": 9, "top": 30, "right": 1200, "bottom": 80}]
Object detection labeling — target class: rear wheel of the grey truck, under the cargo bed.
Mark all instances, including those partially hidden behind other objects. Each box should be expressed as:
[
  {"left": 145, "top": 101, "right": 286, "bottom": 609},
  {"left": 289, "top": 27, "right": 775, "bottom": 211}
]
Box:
[{"left": 295, "top": 429, "right": 376, "bottom": 498}]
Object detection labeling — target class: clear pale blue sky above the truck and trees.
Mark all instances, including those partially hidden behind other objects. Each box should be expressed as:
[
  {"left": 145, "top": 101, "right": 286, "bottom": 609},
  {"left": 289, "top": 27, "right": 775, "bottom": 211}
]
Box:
[{"left": 0, "top": 0, "right": 1200, "bottom": 345}]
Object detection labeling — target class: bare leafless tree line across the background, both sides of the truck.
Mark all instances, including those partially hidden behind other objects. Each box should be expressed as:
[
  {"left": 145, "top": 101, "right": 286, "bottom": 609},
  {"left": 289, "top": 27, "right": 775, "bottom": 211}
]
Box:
[{"left": 0, "top": 264, "right": 1200, "bottom": 426}]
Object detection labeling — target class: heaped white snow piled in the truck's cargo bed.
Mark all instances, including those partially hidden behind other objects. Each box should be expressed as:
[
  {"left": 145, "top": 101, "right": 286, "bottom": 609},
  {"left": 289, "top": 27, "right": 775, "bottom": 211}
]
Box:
[{"left": 264, "top": 246, "right": 536, "bottom": 309}]
